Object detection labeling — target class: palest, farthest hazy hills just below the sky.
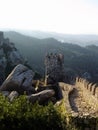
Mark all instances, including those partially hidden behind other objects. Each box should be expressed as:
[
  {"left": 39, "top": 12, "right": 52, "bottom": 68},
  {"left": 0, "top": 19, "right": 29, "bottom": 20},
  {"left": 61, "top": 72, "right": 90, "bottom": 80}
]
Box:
[{"left": 12, "top": 30, "right": 98, "bottom": 46}]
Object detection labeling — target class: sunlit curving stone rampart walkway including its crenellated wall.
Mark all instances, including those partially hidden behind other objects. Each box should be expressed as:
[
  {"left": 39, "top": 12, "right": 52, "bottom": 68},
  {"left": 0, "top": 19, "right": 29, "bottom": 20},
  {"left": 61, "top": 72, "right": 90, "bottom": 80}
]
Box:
[{"left": 59, "top": 79, "right": 98, "bottom": 116}]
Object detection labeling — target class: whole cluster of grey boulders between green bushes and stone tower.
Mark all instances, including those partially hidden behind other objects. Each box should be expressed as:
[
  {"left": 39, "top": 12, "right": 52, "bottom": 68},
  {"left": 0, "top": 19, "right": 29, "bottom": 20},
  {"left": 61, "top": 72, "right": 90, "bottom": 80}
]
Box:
[{"left": 0, "top": 64, "right": 55, "bottom": 105}]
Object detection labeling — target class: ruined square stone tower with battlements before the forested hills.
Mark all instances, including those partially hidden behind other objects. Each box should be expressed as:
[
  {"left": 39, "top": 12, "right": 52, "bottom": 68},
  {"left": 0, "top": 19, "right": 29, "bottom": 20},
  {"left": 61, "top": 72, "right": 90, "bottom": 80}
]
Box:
[{"left": 45, "top": 53, "right": 65, "bottom": 83}]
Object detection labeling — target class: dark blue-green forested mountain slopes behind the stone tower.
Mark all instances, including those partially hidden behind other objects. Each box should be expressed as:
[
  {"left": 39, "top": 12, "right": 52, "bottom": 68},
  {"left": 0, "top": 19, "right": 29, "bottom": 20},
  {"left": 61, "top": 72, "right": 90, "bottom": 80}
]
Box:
[{"left": 4, "top": 32, "right": 98, "bottom": 81}]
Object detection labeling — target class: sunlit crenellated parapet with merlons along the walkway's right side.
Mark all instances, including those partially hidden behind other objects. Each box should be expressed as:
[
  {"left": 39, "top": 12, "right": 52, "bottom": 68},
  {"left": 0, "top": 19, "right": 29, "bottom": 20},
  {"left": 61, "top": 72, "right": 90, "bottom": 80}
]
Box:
[{"left": 76, "top": 78, "right": 98, "bottom": 111}]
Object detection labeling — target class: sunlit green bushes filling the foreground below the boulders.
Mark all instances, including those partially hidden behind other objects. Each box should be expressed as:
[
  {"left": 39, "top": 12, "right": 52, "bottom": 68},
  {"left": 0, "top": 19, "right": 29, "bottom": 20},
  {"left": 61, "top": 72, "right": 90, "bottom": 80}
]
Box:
[{"left": 0, "top": 94, "right": 75, "bottom": 130}]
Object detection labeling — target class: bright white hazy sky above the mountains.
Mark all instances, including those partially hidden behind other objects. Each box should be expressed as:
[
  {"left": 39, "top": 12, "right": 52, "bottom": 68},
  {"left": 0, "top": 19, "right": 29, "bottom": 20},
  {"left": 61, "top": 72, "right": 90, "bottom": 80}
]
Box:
[{"left": 0, "top": 0, "right": 98, "bottom": 34}]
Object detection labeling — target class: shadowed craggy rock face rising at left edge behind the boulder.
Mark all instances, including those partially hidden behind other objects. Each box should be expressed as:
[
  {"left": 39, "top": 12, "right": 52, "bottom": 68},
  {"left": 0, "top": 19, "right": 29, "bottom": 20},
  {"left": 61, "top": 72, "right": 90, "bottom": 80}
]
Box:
[{"left": 0, "top": 32, "right": 25, "bottom": 85}]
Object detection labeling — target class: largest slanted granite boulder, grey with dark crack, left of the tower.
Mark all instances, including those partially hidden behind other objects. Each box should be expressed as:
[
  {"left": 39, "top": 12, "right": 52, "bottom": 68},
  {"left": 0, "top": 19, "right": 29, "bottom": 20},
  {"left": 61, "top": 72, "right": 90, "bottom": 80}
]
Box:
[{"left": 0, "top": 64, "right": 34, "bottom": 93}]
